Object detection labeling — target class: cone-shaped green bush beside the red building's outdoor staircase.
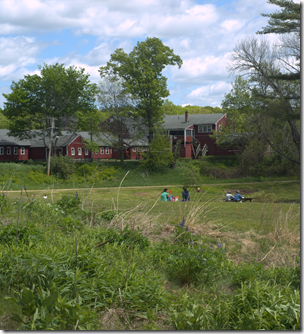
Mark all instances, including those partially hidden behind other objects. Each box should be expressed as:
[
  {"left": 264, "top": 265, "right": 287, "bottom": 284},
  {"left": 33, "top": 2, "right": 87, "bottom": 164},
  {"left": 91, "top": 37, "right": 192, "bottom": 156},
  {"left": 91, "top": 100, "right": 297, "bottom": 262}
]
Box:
[{"left": 140, "top": 131, "right": 173, "bottom": 170}]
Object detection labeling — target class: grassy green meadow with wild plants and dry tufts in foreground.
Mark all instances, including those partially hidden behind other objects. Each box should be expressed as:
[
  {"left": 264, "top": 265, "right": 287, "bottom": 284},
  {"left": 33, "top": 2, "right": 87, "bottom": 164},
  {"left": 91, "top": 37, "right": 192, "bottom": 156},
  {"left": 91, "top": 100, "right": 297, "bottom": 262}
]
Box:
[{"left": 0, "top": 160, "right": 300, "bottom": 330}]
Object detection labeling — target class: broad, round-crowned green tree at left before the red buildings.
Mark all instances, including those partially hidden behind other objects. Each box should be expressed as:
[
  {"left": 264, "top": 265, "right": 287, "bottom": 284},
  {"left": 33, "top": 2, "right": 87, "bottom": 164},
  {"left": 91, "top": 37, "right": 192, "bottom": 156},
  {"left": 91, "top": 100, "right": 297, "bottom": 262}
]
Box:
[{"left": 3, "top": 63, "right": 96, "bottom": 153}]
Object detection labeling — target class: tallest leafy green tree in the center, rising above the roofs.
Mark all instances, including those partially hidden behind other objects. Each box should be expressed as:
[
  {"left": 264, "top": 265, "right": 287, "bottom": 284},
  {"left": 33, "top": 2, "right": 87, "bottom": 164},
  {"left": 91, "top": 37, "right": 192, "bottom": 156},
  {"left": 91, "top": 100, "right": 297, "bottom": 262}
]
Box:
[{"left": 99, "top": 37, "right": 183, "bottom": 143}]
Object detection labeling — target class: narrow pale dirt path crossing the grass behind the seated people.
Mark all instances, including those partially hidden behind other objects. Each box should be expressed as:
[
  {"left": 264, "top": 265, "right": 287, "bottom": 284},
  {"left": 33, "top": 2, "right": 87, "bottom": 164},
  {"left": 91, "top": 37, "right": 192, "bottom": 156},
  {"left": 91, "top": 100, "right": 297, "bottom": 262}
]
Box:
[{"left": 5, "top": 180, "right": 300, "bottom": 193}]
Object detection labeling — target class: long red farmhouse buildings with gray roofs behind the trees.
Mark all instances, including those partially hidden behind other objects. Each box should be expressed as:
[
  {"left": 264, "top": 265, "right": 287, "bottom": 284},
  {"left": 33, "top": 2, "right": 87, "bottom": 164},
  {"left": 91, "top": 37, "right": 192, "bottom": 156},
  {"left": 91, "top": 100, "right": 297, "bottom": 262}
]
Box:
[{"left": 0, "top": 111, "right": 238, "bottom": 161}]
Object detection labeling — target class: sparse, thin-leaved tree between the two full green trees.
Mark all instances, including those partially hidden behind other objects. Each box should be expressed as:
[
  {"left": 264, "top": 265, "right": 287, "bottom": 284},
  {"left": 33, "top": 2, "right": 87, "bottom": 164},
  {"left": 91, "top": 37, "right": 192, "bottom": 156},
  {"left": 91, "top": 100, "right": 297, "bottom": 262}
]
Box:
[{"left": 95, "top": 73, "right": 143, "bottom": 165}]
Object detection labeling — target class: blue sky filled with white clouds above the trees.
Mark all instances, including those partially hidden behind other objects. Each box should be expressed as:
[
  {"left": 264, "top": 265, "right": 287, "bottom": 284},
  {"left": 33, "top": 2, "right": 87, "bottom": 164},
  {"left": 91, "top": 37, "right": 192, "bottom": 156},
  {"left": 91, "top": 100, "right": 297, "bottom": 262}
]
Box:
[{"left": 0, "top": 0, "right": 290, "bottom": 107}]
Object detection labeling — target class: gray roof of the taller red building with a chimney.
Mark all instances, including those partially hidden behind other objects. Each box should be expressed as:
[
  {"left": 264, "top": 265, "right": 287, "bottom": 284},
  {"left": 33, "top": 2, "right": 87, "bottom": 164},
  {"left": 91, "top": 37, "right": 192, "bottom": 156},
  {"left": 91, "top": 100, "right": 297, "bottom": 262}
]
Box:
[{"left": 162, "top": 113, "right": 225, "bottom": 130}]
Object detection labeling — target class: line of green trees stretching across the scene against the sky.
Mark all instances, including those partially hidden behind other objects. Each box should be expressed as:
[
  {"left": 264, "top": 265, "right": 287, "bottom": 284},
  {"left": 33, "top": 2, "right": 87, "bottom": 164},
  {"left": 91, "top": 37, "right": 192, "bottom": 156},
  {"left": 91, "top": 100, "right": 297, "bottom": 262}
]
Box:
[{"left": 0, "top": 0, "right": 300, "bottom": 171}]
